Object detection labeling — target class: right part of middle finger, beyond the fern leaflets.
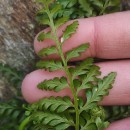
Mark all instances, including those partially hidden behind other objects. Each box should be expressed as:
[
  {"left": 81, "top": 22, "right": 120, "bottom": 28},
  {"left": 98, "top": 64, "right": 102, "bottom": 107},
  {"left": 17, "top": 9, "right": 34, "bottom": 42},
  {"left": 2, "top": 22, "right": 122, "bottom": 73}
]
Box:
[{"left": 97, "top": 60, "right": 130, "bottom": 105}]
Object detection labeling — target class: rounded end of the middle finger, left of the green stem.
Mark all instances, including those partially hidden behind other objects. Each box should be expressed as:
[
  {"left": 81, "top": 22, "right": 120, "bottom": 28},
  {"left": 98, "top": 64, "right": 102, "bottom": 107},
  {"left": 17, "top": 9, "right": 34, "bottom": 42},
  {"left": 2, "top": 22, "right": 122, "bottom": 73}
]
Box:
[{"left": 21, "top": 70, "right": 72, "bottom": 103}]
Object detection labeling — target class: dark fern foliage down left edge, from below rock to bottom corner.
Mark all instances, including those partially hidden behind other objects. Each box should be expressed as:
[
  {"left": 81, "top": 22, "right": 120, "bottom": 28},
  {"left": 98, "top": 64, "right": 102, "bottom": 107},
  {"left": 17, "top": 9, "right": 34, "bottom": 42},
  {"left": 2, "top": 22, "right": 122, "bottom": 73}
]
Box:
[{"left": 0, "top": 64, "right": 32, "bottom": 130}]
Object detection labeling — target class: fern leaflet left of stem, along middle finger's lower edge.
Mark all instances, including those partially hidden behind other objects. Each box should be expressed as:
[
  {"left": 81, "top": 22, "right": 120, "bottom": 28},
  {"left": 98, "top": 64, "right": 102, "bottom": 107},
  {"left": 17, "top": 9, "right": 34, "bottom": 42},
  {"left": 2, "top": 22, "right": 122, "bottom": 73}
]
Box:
[{"left": 31, "top": 97, "right": 74, "bottom": 113}]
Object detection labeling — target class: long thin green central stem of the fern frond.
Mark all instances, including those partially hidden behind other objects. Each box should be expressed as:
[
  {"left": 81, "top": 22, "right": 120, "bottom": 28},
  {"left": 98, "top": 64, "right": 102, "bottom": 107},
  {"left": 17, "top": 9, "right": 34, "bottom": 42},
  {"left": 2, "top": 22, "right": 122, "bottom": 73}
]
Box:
[{"left": 47, "top": 10, "right": 79, "bottom": 130}]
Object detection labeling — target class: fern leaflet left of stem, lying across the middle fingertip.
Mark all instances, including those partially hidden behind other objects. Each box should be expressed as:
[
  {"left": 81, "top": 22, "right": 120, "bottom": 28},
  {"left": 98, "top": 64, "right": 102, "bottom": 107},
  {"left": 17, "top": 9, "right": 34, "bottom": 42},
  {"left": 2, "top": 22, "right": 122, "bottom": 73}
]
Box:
[{"left": 38, "top": 77, "right": 68, "bottom": 92}]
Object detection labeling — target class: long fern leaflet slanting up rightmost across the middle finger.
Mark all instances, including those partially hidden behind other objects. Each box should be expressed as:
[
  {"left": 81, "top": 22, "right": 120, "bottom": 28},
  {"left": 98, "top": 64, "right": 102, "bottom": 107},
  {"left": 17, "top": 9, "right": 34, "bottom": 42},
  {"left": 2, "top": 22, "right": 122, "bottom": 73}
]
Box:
[{"left": 80, "top": 72, "right": 116, "bottom": 112}]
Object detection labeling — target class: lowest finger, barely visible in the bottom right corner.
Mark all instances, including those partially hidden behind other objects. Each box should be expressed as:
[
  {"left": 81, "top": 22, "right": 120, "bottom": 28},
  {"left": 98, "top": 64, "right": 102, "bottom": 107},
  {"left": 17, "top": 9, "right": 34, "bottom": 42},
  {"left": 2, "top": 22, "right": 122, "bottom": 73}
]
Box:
[{"left": 106, "top": 118, "right": 130, "bottom": 130}]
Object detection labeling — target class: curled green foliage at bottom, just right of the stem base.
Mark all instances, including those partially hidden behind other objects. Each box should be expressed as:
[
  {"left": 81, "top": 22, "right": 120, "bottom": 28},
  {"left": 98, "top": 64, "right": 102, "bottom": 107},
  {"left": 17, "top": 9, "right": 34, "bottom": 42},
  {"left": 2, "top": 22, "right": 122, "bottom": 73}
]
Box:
[{"left": 80, "top": 106, "right": 109, "bottom": 130}]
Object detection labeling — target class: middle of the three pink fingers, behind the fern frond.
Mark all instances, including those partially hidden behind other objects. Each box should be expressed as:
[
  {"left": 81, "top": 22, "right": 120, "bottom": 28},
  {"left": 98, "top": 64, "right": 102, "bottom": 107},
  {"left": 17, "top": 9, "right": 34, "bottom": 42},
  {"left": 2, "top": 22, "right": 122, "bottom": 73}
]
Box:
[{"left": 22, "top": 60, "right": 130, "bottom": 105}]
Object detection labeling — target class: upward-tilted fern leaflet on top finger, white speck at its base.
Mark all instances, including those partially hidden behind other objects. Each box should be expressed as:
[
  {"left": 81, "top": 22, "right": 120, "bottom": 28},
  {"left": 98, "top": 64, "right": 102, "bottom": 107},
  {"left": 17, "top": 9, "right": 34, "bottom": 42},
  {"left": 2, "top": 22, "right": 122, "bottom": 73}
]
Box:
[{"left": 62, "top": 21, "right": 78, "bottom": 42}]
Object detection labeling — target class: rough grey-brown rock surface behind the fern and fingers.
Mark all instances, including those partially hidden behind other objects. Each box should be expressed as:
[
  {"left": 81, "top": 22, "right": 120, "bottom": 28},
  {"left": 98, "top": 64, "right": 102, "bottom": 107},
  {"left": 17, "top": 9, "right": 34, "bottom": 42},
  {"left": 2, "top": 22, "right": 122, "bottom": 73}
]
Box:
[{"left": 0, "top": 0, "right": 130, "bottom": 98}]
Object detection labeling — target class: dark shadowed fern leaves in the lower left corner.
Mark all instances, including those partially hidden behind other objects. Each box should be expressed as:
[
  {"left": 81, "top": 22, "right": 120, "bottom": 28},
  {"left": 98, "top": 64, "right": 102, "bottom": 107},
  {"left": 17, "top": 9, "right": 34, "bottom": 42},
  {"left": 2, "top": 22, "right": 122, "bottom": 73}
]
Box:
[{"left": 0, "top": 99, "right": 25, "bottom": 130}]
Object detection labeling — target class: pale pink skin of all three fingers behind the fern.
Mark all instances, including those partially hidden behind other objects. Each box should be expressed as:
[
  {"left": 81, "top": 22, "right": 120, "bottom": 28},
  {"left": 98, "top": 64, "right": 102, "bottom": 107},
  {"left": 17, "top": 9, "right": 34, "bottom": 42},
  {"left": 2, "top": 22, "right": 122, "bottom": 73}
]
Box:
[{"left": 22, "top": 11, "right": 130, "bottom": 130}]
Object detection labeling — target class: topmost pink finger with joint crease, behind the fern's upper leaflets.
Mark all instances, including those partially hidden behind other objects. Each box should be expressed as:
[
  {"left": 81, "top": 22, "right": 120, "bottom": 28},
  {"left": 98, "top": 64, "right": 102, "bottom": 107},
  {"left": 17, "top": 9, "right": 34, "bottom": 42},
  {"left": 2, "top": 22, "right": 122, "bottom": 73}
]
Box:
[{"left": 34, "top": 11, "right": 130, "bottom": 60}]
